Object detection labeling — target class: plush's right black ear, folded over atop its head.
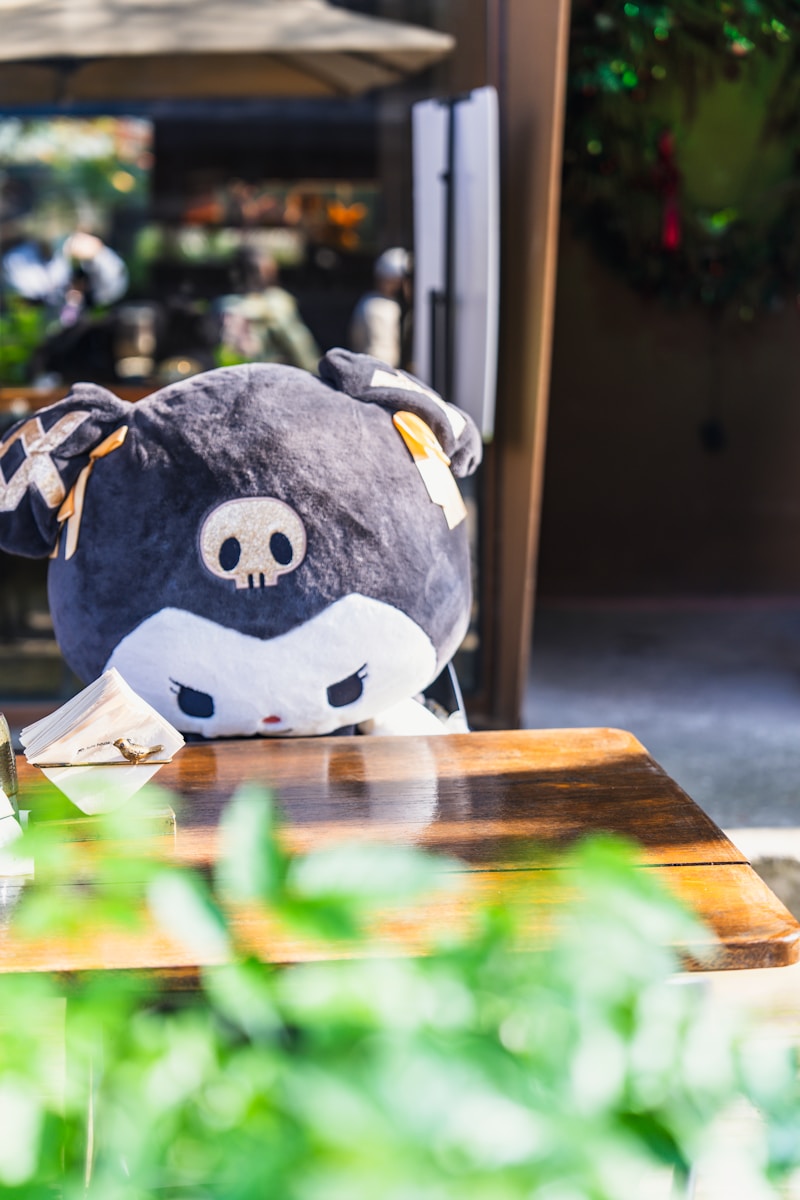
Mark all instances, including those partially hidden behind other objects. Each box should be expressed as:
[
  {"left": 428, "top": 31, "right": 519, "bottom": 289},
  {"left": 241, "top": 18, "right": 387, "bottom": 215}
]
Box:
[{"left": 319, "top": 349, "right": 483, "bottom": 476}]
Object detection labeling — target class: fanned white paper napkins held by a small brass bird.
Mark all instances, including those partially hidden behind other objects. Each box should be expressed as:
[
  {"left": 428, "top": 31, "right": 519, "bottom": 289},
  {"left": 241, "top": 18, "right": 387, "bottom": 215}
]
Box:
[{"left": 19, "top": 668, "right": 184, "bottom": 816}]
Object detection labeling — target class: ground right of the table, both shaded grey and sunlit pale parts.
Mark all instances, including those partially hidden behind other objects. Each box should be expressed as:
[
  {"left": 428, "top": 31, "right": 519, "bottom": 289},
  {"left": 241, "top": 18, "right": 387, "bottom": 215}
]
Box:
[{"left": 523, "top": 600, "right": 800, "bottom": 1200}]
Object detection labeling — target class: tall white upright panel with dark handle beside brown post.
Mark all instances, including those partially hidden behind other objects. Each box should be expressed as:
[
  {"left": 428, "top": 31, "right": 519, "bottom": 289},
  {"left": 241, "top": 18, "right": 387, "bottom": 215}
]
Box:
[{"left": 411, "top": 88, "right": 500, "bottom": 438}]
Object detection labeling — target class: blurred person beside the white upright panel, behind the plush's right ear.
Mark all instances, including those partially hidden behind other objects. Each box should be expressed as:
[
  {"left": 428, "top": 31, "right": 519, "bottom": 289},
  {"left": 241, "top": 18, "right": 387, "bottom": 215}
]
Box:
[{"left": 348, "top": 246, "right": 411, "bottom": 367}]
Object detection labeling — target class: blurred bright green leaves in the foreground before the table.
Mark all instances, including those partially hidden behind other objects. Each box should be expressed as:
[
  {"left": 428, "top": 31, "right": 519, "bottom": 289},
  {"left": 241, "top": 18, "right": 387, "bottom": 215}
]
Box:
[{"left": 0, "top": 787, "right": 800, "bottom": 1200}]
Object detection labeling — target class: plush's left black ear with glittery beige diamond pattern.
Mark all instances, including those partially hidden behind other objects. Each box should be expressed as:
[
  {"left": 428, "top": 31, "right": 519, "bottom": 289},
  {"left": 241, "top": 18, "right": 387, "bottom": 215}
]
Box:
[{"left": 0, "top": 383, "right": 131, "bottom": 558}]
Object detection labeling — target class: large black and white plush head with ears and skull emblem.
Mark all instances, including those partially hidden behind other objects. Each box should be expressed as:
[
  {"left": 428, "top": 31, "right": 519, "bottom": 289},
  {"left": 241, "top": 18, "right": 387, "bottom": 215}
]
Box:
[{"left": 0, "top": 350, "right": 480, "bottom": 737}]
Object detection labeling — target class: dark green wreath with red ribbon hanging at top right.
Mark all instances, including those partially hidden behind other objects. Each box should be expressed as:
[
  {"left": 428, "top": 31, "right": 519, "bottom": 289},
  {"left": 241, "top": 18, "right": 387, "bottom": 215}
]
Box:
[{"left": 563, "top": 0, "right": 800, "bottom": 320}]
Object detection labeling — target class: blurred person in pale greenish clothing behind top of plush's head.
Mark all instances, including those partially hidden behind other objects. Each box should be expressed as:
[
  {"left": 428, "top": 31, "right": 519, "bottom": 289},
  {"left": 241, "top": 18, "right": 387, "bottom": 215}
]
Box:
[{"left": 213, "top": 246, "right": 320, "bottom": 374}]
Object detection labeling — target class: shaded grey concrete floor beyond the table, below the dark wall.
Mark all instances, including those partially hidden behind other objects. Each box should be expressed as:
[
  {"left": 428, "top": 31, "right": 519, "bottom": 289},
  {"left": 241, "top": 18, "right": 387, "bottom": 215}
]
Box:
[{"left": 523, "top": 600, "right": 800, "bottom": 829}]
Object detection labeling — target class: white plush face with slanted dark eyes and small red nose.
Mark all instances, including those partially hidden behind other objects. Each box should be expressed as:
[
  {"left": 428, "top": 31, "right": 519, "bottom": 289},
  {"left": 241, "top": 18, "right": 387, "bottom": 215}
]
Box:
[{"left": 106, "top": 594, "right": 437, "bottom": 738}]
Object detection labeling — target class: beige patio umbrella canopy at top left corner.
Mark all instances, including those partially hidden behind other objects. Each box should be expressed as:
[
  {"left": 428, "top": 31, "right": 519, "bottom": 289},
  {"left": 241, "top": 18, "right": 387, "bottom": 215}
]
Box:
[{"left": 0, "top": 0, "right": 455, "bottom": 110}]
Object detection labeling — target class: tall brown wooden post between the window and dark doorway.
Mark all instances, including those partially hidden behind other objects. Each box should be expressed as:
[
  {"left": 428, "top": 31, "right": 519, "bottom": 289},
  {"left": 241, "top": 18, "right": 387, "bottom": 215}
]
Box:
[{"left": 481, "top": 0, "right": 570, "bottom": 728}]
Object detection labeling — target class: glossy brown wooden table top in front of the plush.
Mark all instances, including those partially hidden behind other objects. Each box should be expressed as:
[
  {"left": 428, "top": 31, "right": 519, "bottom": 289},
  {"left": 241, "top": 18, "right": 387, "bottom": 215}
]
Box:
[{"left": 6, "top": 728, "right": 800, "bottom": 986}]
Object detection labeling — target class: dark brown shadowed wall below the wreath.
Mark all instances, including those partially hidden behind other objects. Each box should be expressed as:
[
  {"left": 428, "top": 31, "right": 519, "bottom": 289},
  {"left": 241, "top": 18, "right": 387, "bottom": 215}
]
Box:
[{"left": 539, "top": 235, "right": 800, "bottom": 596}]
